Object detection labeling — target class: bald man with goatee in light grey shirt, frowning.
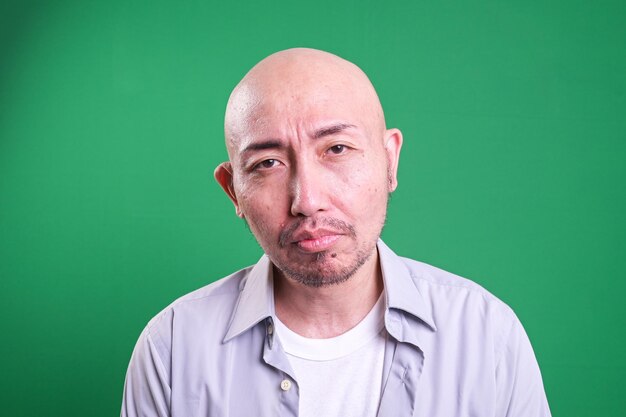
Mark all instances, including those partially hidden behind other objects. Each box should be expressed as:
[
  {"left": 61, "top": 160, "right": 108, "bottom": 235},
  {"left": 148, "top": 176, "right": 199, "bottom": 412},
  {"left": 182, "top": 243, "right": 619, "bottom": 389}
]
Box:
[{"left": 122, "top": 49, "right": 550, "bottom": 417}]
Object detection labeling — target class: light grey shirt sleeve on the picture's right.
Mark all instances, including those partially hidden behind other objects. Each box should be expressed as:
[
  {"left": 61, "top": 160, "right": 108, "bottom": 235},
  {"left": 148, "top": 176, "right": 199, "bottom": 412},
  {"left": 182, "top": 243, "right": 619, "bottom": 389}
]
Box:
[{"left": 496, "top": 317, "right": 550, "bottom": 417}]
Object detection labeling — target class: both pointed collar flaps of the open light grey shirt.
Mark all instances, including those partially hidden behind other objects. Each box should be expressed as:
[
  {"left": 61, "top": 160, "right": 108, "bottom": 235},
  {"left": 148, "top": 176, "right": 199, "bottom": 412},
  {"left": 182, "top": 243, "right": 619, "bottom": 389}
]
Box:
[{"left": 224, "top": 239, "right": 437, "bottom": 342}]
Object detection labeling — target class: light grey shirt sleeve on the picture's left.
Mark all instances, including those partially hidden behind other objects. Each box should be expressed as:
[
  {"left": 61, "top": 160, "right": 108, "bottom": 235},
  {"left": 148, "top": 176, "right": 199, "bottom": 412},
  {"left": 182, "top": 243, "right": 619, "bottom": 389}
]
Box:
[{"left": 121, "top": 331, "right": 171, "bottom": 417}]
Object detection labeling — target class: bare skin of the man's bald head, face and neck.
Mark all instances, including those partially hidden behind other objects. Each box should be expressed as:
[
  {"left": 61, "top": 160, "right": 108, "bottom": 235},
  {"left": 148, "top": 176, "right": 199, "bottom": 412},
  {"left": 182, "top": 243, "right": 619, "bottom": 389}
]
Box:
[{"left": 215, "top": 48, "right": 402, "bottom": 338}]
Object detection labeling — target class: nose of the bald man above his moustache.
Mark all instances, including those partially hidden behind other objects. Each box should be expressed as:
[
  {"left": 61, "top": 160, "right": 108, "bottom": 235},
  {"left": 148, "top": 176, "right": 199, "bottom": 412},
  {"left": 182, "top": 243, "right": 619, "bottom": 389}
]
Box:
[{"left": 290, "top": 160, "right": 328, "bottom": 217}]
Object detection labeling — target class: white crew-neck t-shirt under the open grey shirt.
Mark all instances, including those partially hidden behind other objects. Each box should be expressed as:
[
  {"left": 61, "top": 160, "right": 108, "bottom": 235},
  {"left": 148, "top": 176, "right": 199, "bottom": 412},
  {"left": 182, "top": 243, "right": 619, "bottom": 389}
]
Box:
[{"left": 275, "top": 295, "right": 386, "bottom": 417}]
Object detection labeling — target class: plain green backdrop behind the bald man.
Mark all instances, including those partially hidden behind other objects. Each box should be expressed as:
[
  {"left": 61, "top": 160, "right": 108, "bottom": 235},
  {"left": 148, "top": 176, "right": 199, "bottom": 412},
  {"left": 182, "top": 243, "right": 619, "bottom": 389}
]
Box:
[{"left": 0, "top": 0, "right": 626, "bottom": 416}]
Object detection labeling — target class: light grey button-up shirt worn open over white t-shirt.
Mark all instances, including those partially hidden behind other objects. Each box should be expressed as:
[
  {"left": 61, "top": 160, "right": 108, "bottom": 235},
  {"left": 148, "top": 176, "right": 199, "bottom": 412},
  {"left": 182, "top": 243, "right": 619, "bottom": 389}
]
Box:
[{"left": 121, "top": 240, "right": 550, "bottom": 417}]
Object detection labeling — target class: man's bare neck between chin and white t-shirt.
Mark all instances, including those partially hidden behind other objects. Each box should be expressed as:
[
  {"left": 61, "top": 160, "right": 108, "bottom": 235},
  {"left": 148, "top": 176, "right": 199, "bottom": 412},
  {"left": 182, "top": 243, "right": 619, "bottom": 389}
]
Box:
[{"left": 274, "top": 249, "right": 383, "bottom": 339}]
